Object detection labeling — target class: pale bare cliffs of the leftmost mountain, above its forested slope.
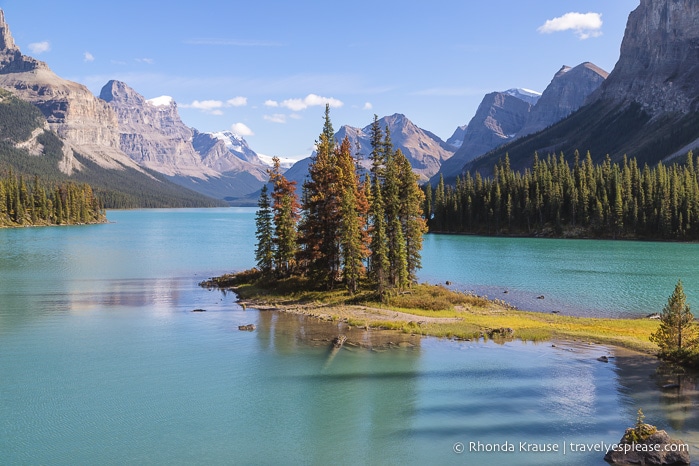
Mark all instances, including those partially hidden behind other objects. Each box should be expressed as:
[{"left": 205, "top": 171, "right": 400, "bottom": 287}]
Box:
[{"left": 0, "top": 11, "right": 140, "bottom": 173}]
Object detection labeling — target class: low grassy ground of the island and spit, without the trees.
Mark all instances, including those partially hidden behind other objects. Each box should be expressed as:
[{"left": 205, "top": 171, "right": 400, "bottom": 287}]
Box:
[{"left": 201, "top": 269, "right": 659, "bottom": 353}]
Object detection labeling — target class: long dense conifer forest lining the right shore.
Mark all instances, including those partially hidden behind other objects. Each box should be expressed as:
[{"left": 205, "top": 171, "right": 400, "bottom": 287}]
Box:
[{"left": 424, "top": 151, "right": 699, "bottom": 240}]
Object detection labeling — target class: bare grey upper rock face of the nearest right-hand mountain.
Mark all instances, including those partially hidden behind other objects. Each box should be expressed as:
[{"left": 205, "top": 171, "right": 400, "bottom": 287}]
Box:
[{"left": 591, "top": 0, "right": 699, "bottom": 116}]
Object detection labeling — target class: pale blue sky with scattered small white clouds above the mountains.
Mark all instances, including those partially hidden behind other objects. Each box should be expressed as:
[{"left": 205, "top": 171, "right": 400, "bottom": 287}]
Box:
[{"left": 0, "top": 0, "right": 639, "bottom": 158}]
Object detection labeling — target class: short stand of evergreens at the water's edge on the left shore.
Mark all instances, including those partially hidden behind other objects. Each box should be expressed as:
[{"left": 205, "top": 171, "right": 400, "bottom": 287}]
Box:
[{"left": 0, "top": 172, "right": 106, "bottom": 226}]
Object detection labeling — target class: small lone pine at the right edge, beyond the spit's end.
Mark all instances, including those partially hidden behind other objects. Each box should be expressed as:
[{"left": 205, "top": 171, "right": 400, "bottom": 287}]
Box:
[{"left": 650, "top": 280, "right": 699, "bottom": 362}]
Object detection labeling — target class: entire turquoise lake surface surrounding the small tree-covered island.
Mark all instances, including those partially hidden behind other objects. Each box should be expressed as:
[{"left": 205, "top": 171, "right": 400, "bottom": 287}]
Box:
[{"left": 0, "top": 209, "right": 699, "bottom": 465}]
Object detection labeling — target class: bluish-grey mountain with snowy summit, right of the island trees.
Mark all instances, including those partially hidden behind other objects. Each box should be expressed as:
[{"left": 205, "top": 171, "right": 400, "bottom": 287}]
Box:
[{"left": 432, "top": 90, "right": 534, "bottom": 183}]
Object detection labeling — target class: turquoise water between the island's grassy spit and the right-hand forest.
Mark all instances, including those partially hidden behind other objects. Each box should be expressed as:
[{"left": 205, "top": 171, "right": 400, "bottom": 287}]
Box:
[{"left": 420, "top": 235, "right": 699, "bottom": 317}]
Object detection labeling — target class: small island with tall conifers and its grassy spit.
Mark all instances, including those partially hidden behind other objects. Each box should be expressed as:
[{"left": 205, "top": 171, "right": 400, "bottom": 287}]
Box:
[{"left": 201, "top": 106, "right": 680, "bottom": 353}]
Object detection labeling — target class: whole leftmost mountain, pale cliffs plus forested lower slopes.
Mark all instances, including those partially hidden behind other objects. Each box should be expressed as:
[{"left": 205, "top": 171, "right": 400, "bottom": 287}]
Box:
[{"left": 0, "top": 10, "right": 220, "bottom": 208}]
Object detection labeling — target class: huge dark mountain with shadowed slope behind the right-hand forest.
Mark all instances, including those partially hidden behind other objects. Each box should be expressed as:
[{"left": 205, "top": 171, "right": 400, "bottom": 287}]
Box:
[{"left": 465, "top": 0, "right": 699, "bottom": 177}]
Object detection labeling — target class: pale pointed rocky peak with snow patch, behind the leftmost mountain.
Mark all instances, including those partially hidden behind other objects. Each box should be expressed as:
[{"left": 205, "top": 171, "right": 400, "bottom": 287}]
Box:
[{"left": 100, "top": 81, "right": 217, "bottom": 179}]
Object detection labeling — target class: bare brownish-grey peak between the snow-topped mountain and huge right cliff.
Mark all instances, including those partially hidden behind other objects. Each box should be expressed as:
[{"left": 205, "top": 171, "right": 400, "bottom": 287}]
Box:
[{"left": 517, "top": 62, "right": 609, "bottom": 138}]
